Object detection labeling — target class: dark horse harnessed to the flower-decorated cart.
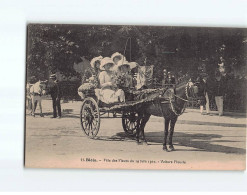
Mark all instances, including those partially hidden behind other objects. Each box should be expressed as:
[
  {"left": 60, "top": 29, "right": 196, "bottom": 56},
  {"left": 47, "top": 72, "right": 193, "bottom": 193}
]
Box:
[{"left": 136, "top": 79, "right": 198, "bottom": 151}]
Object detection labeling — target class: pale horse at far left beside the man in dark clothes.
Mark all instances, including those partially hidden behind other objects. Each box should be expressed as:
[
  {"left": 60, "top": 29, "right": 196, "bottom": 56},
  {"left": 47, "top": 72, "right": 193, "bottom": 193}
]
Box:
[{"left": 29, "top": 80, "right": 48, "bottom": 117}]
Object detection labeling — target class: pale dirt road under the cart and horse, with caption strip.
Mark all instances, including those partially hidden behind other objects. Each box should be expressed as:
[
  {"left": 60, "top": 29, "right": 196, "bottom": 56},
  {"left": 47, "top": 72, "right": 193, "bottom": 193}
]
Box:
[{"left": 25, "top": 100, "right": 246, "bottom": 170}]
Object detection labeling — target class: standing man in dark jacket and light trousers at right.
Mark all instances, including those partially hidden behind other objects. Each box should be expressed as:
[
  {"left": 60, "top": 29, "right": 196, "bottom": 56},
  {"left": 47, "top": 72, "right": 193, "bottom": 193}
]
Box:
[{"left": 214, "top": 72, "right": 226, "bottom": 116}]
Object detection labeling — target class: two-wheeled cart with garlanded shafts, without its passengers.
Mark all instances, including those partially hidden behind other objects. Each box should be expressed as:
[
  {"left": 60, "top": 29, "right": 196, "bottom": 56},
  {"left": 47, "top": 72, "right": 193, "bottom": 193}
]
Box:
[{"left": 80, "top": 88, "right": 169, "bottom": 138}]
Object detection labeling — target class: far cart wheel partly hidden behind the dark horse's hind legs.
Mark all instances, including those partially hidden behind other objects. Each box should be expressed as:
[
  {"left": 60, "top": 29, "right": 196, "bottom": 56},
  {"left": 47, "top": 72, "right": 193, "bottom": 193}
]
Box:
[{"left": 122, "top": 112, "right": 138, "bottom": 136}]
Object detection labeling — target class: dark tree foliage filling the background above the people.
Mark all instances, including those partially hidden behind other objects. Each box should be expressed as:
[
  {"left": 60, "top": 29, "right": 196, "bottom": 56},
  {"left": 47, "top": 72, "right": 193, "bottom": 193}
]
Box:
[{"left": 27, "top": 24, "right": 247, "bottom": 79}]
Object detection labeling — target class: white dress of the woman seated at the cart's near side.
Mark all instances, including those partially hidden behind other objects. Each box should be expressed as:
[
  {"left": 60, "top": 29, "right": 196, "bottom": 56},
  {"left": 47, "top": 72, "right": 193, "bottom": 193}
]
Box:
[{"left": 95, "top": 71, "right": 125, "bottom": 104}]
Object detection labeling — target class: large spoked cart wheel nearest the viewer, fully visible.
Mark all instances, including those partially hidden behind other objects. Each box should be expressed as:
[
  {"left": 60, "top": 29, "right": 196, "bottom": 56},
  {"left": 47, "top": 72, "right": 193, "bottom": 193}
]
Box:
[{"left": 80, "top": 97, "right": 100, "bottom": 138}]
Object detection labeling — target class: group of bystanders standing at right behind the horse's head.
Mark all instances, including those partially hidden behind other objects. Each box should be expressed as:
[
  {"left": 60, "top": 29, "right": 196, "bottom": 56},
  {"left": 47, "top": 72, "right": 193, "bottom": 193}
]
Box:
[{"left": 194, "top": 57, "right": 247, "bottom": 116}]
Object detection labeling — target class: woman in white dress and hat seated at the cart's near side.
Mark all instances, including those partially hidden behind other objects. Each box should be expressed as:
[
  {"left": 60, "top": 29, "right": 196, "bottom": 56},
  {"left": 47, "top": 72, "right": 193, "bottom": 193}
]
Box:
[{"left": 95, "top": 57, "right": 125, "bottom": 104}]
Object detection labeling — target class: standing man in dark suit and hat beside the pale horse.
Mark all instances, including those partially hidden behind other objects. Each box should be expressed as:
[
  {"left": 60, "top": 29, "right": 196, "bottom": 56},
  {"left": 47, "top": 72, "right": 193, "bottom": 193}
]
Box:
[{"left": 50, "top": 74, "right": 61, "bottom": 118}]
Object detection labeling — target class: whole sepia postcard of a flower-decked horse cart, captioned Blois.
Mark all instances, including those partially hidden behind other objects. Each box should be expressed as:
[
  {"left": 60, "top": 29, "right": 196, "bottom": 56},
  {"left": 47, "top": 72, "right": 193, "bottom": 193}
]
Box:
[{"left": 24, "top": 23, "right": 247, "bottom": 171}]
